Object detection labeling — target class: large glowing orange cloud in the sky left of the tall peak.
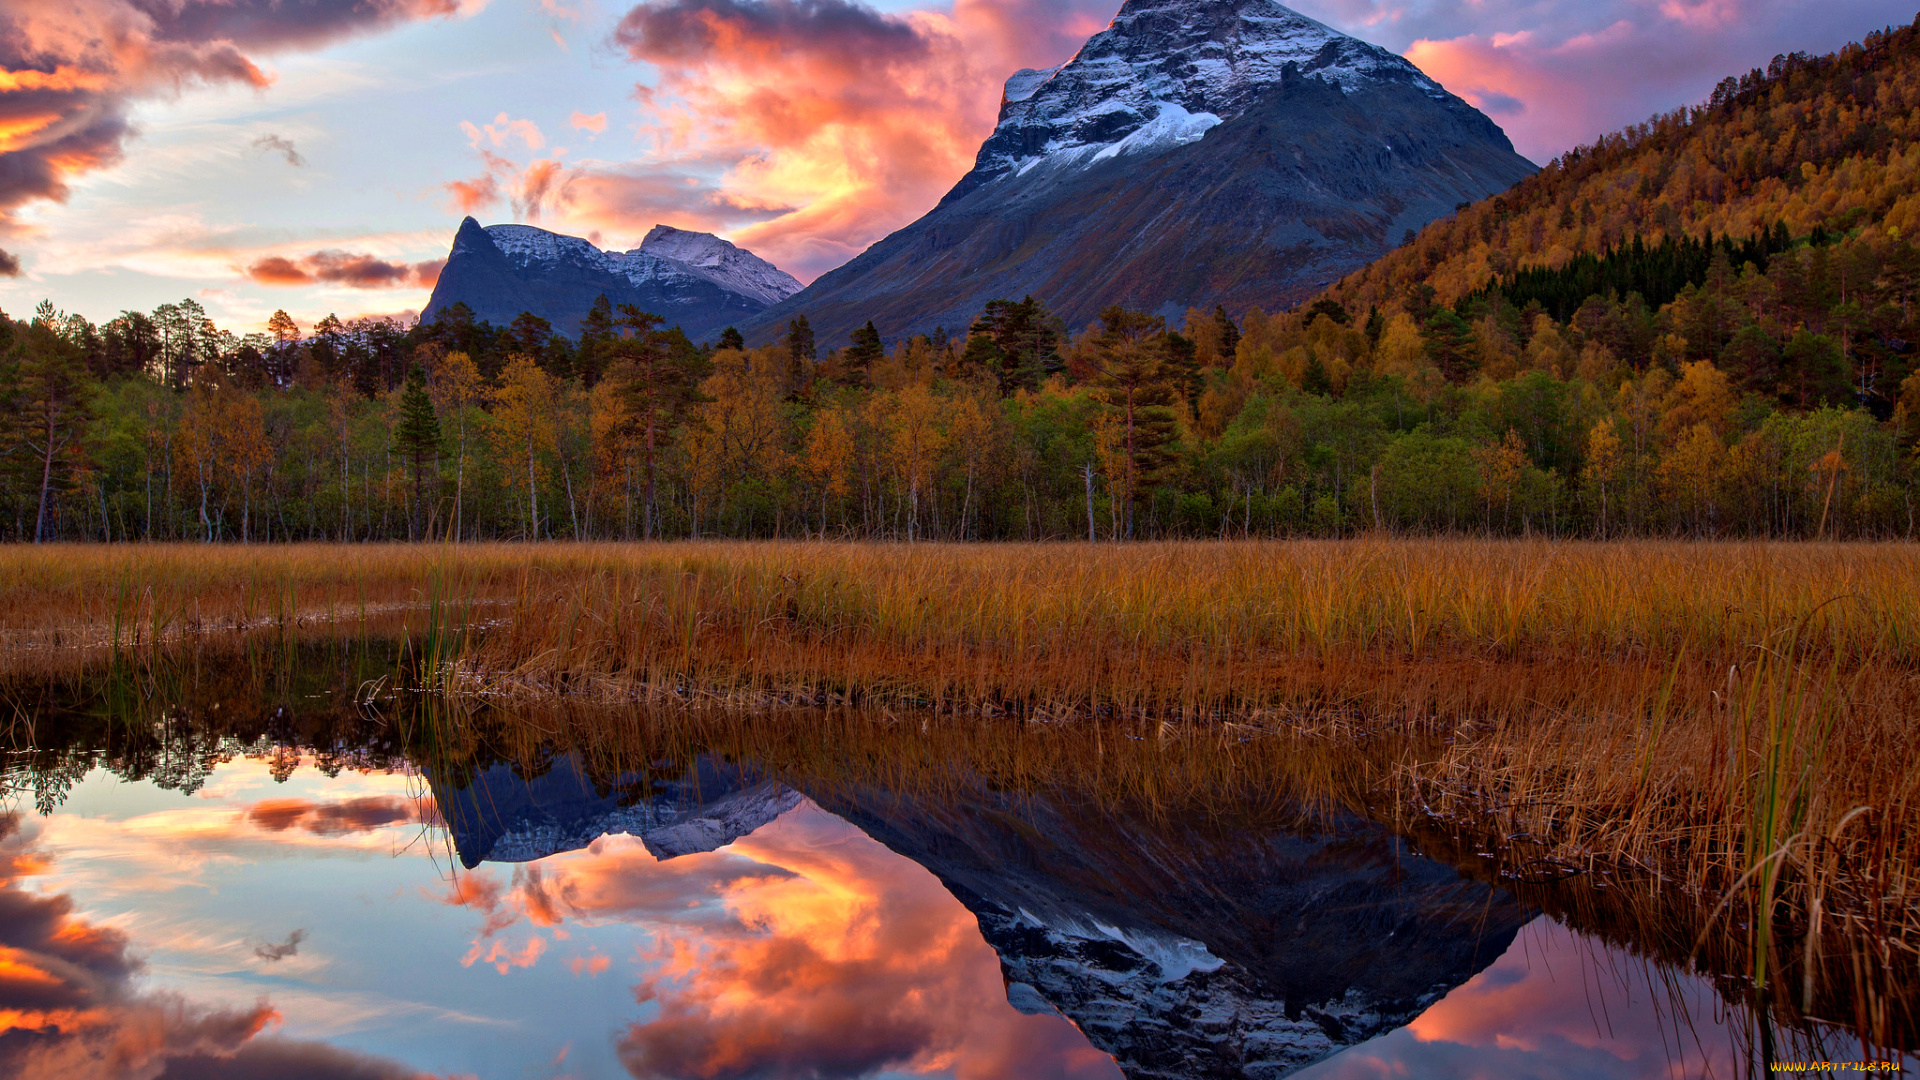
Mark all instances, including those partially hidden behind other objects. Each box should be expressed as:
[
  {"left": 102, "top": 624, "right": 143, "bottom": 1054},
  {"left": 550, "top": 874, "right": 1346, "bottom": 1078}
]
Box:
[{"left": 480, "top": 0, "right": 1114, "bottom": 281}]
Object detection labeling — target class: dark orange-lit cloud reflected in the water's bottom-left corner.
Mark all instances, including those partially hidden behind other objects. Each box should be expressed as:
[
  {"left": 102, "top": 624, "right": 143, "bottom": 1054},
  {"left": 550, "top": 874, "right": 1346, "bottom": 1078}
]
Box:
[{"left": 0, "top": 815, "right": 439, "bottom": 1080}]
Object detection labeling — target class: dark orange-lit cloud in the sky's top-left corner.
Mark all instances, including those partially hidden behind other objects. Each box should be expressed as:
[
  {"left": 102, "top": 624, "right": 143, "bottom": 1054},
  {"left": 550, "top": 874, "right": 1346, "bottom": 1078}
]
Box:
[{"left": 0, "top": 0, "right": 457, "bottom": 242}]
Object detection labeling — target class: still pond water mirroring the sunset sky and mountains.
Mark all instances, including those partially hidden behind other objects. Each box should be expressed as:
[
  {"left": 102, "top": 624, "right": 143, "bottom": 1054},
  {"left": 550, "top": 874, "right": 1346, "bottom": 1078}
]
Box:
[{"left": 0, "top": 653, "right": 1912, "bottom": 1080}]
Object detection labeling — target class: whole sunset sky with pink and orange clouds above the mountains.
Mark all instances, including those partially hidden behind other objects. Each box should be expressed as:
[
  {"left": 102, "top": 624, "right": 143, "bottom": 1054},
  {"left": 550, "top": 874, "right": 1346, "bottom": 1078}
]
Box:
[{"left": 0, "top": 0, "right": 1914, "bottom": 332}]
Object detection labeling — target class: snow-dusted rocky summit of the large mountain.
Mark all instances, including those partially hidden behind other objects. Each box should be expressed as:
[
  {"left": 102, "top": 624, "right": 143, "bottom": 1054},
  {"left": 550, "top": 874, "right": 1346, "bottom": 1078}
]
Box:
[{"left": 973, "top": 0, "right": 1450, "bottom": 177}]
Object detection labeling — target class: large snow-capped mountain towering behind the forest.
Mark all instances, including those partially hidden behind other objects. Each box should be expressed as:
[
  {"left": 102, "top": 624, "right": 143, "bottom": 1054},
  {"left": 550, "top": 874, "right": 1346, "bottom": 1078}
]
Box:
[{"left": 753, "top": 0, "right": 1534, "bottom": 342}]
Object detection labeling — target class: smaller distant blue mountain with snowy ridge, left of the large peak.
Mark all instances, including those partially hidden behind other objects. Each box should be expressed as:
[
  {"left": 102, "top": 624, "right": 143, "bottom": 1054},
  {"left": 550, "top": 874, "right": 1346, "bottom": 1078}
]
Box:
[{"left": 422, "top": 217, "right": 801, "bottom": 340}]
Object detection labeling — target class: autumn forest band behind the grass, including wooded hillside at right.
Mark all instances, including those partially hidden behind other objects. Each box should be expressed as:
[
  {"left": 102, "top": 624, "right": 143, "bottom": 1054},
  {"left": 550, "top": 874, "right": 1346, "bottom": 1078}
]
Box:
[{"left": 11, "top": 15, "right": 1920, "bottom": 540}]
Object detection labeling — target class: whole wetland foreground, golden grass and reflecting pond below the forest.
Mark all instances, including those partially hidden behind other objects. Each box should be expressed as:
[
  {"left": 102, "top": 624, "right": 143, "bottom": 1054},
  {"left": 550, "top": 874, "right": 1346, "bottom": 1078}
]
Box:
[{"left": 0, "top": 542, "right": 1920, "bottom": 1078}]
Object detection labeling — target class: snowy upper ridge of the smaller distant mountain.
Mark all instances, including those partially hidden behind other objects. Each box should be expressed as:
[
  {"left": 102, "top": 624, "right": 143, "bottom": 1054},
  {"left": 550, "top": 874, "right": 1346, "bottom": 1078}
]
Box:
[{"left": 486, "top": 225, "right": 801, "bottom": 304}]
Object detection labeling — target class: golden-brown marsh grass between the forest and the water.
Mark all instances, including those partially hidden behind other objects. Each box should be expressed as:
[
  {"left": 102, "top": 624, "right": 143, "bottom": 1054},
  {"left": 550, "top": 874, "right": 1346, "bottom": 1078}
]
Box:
[{"left": 0, "top": 540, "right": 1920, "bottom": 1014}]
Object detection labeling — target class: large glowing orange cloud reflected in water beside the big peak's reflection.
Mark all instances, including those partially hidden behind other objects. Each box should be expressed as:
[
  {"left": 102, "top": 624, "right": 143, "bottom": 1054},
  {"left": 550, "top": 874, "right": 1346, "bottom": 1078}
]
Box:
[{"left": 433, "top": 803, "right": 1119, "bottom": 1080}]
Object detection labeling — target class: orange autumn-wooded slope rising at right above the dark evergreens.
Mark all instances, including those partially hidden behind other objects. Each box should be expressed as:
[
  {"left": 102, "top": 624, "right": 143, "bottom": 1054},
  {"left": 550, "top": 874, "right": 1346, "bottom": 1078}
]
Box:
[{"left": 1329, "top": 25, "right": 1920, "bottom": 320}]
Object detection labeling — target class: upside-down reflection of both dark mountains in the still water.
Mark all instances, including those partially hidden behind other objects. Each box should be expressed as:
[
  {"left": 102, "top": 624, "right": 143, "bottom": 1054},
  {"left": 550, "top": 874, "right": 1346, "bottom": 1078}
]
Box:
[{"left": 428, "top": 753, "right": 1532, "bottom": 1080}]
